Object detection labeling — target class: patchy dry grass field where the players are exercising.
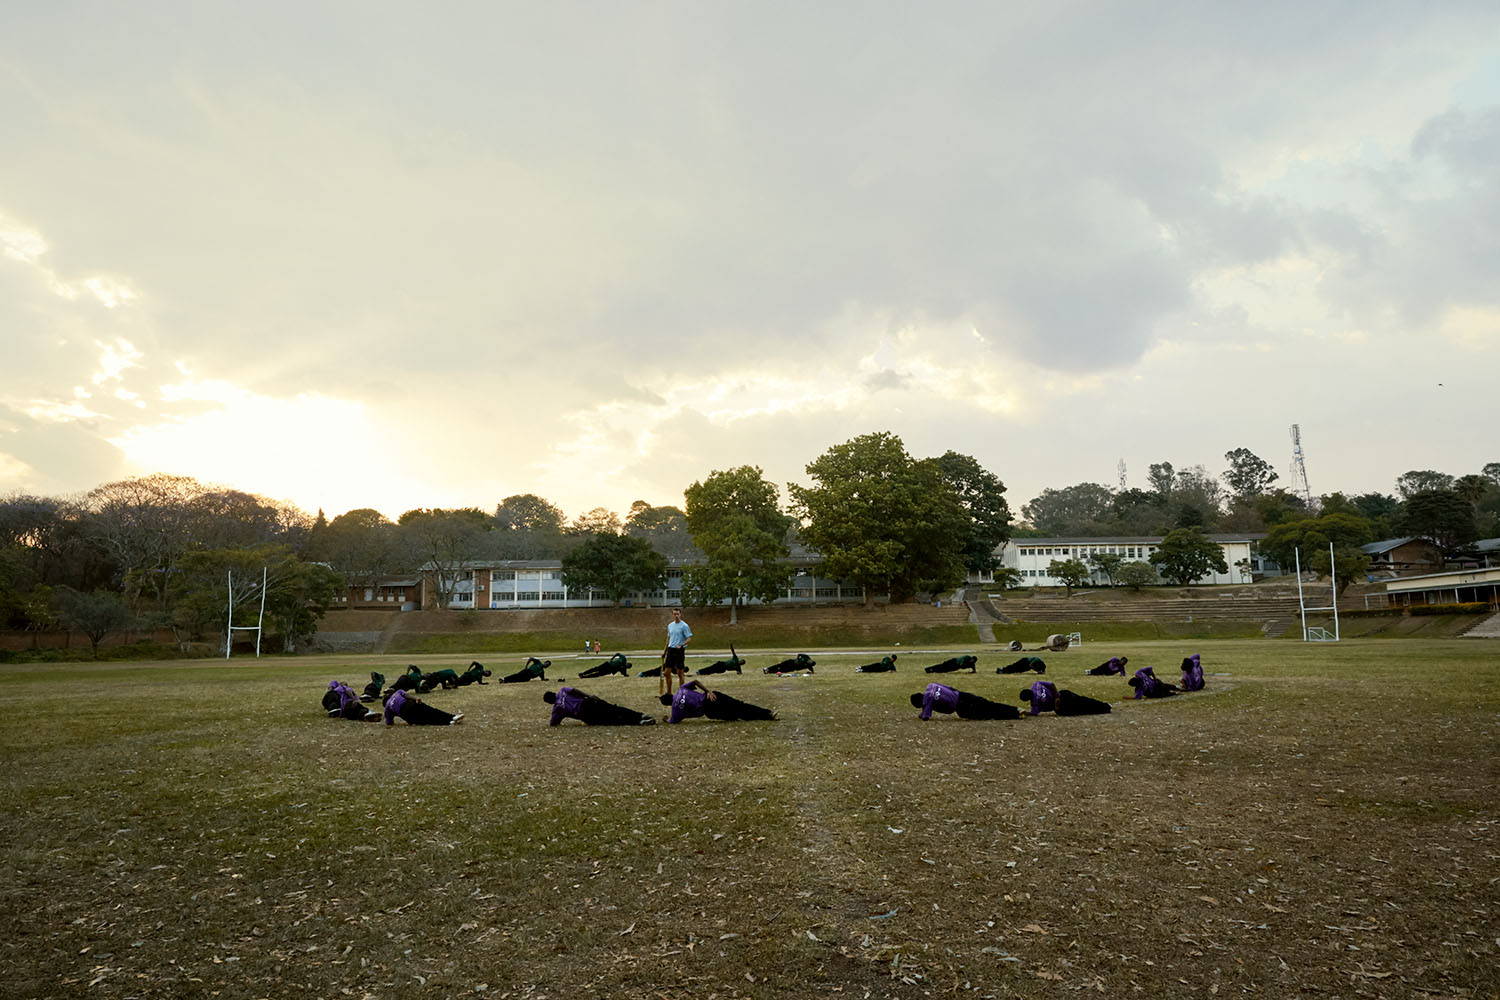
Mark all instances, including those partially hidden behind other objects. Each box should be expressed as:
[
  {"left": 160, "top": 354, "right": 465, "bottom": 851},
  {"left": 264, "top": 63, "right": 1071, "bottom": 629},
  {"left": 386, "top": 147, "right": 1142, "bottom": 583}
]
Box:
[{"left": 0, "top": 639, "right": 1500, "bottom": 1000}]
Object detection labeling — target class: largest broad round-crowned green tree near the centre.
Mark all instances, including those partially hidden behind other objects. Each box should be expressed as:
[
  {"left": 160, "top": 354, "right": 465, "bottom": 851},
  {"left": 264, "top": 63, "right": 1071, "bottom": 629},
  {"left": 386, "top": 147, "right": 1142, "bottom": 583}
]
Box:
[{"left": 788, "top": 432, "right": 971, "bottom": 606}]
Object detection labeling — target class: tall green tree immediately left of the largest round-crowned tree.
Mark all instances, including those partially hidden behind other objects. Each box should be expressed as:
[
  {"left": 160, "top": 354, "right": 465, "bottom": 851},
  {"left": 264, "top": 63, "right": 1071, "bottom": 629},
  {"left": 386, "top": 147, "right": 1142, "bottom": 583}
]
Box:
[{"left": 683, "top": 465, "right": 792, "bottom": 624}]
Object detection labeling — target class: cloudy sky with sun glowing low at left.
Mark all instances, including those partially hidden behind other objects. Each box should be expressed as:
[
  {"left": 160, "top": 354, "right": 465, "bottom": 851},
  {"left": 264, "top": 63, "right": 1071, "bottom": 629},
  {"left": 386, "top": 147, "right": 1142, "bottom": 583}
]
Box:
[{"left": 0, "top": 0, "right": 1500, "bottom": 517}]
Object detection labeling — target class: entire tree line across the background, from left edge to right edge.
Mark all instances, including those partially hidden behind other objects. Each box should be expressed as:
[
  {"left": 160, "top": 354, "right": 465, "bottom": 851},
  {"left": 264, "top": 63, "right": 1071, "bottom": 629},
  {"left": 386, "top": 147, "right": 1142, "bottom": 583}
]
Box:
[{"left": 0, "top": 432, "right": 1500, "bottom": 649}]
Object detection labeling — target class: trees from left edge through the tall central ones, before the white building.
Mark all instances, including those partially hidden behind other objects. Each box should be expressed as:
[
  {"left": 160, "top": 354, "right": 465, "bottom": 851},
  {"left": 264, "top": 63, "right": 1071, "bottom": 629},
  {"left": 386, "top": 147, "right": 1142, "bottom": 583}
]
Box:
[{"left": 0, "top": 433, "right": 1011, "bottom": 654}]
